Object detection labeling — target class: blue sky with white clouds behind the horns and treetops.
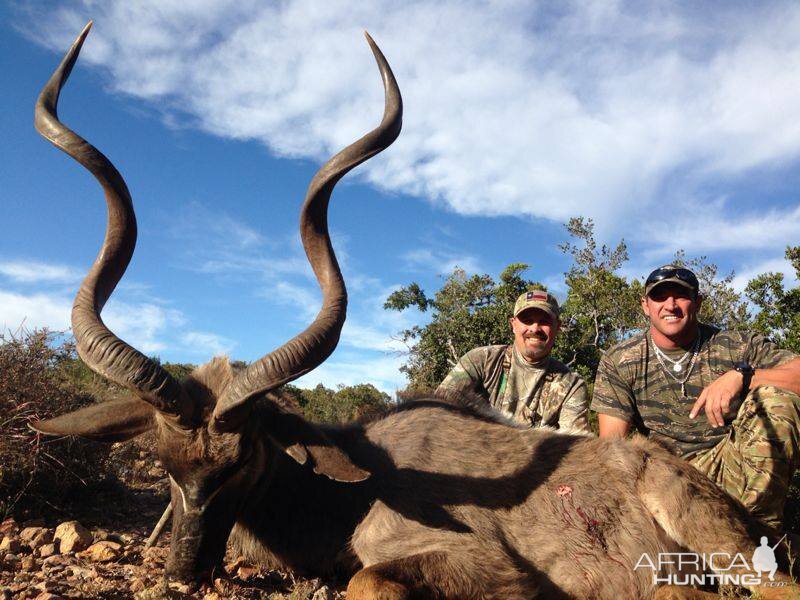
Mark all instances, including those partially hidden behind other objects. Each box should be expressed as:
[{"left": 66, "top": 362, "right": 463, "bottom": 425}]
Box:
[{"left": 0, "top": 0, "right": 800, "bottom": 393}]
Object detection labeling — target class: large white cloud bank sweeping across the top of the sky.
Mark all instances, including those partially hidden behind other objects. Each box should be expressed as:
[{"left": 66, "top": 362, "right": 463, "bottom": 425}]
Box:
[{"left": 17, "top": 0, "right": 800, "bottom": 237}]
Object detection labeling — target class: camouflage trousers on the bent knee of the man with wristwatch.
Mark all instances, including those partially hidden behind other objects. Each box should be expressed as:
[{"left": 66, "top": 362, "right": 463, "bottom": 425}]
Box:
[{"left": 689, "top": 386, "right": 800, "bottom": 528}]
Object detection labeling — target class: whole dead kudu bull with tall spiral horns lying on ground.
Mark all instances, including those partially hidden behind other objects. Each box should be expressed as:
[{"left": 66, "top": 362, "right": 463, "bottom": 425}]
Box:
[{"left": 32, "top": 26, "right": 800, "bottom": 600}]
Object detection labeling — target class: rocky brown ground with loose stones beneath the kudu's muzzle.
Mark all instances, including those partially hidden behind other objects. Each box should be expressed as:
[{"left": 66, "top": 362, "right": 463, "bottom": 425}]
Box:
[{"left": 0, "top": 450, "right": 344, "bottom": 600}]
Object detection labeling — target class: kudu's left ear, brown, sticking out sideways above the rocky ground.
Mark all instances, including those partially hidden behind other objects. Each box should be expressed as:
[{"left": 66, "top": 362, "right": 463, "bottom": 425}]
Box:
[{"left": 30, "top": 398, "right": 155, "bottom": 442}]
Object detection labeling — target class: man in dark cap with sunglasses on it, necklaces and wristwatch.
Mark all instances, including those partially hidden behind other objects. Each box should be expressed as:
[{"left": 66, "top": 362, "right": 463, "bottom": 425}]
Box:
[{"left": 592, "top": 265, "right": 800, "bottom": 526}]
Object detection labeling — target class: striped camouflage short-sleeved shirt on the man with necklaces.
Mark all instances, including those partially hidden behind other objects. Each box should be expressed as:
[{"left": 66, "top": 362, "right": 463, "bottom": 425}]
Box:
[{"left": 592, "top": 324, "right": 795, "bottom": 457}]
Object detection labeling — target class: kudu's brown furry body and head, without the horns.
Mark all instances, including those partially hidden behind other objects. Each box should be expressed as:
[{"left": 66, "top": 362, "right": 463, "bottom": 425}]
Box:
[{"left": 32, "top": 358, "right": 800, "bottom": 600}]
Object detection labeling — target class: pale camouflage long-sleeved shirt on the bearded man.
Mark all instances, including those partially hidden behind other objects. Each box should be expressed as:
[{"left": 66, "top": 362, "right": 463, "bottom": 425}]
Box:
[{"left": 439, "top": 345, "right": 590, "bottom": 432}]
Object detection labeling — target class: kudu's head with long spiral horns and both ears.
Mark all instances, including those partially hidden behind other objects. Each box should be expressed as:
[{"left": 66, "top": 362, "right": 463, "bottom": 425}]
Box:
[{"left": 31, "top": 23, "right": 402, "bottom": 581}]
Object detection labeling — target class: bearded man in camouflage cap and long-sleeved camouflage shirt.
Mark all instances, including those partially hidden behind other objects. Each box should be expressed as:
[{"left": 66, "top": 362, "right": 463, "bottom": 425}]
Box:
[{"left": 437, "top": 290, "right": 591, "bottom": 432}]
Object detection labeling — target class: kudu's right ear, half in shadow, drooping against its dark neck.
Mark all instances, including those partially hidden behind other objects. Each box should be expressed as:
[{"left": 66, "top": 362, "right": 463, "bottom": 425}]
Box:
[{"left": 269, "top": 404, "right": 370, "bottom": 483}]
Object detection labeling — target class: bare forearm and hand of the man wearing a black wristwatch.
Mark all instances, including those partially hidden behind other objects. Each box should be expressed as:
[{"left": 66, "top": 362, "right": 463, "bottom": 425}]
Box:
[{"left": 689, "top": 358, "right": 800, "bottom": 427}]
